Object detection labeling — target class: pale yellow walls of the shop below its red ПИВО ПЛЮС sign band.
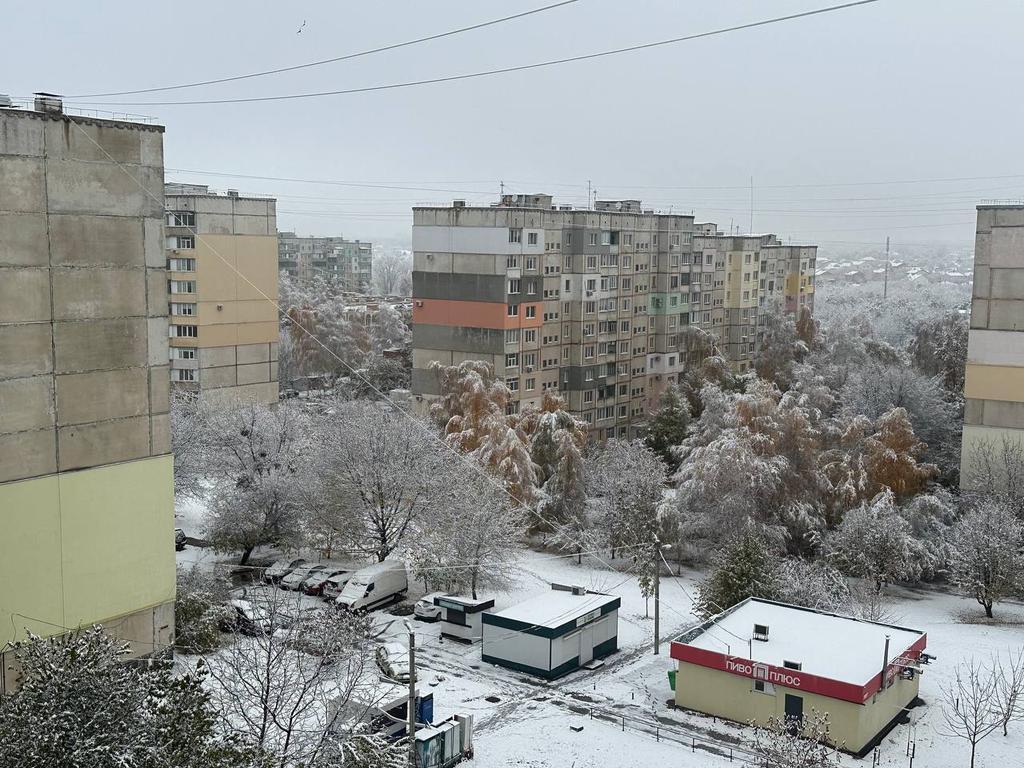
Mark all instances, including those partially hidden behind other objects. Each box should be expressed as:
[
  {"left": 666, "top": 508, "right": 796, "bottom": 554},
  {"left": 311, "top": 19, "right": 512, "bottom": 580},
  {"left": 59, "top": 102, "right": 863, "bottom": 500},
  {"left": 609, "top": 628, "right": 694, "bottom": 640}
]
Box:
[{"left": 676, "top": 662, "right": 919, "bottom": 752}]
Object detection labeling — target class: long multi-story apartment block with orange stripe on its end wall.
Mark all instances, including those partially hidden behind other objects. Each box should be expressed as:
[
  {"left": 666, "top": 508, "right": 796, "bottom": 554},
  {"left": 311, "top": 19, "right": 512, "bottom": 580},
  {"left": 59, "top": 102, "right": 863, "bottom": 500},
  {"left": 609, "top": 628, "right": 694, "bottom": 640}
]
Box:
[{"left": 413, "top": 195, "right": 814, "bottom": 437}]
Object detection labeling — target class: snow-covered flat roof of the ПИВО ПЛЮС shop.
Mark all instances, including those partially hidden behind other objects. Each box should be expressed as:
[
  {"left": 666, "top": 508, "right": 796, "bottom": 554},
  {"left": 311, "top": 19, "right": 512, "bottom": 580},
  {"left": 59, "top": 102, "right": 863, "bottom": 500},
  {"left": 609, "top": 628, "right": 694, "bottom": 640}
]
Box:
[{"left": 676, "top": 598, "right": 925, "bottom": 685}]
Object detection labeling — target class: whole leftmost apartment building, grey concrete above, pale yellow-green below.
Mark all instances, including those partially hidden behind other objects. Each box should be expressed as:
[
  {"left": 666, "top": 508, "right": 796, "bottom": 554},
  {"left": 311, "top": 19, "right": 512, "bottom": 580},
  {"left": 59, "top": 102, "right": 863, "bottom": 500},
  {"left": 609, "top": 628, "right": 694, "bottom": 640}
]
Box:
[{"left": 0, "top": 95, "right": 174, "bottom": 694}]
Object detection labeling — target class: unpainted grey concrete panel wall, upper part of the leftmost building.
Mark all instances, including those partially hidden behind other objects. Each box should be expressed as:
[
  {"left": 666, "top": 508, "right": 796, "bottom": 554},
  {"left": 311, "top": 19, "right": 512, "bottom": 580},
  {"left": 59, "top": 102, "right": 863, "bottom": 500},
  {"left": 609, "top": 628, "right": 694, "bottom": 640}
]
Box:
[{"left": 0, "top": 109, "right": 170, "bottom": 482}]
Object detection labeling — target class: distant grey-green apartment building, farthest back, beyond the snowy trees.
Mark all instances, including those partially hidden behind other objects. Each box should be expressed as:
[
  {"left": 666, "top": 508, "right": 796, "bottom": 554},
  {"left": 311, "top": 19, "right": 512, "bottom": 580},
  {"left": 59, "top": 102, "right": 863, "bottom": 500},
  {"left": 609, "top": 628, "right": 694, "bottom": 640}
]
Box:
[{"left": 278, "top": 232, "right": 374, "bottom": 294}]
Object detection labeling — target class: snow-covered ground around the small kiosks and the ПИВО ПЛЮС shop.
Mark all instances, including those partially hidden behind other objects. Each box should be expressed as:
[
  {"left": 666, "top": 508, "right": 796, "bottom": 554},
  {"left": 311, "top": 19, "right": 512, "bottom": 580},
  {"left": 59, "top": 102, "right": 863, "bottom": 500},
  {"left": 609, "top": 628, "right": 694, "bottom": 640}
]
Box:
[{"left": 178, "top": 499, "right": 1024, "bottom": 768}]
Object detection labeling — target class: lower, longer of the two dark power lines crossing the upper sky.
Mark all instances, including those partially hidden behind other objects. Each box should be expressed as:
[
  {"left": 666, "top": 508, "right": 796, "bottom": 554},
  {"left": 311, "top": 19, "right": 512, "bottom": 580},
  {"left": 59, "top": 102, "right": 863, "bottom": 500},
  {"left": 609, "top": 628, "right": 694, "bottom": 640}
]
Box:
[{"left": 66, "top": 0, "right": 881, "bottom": 106}]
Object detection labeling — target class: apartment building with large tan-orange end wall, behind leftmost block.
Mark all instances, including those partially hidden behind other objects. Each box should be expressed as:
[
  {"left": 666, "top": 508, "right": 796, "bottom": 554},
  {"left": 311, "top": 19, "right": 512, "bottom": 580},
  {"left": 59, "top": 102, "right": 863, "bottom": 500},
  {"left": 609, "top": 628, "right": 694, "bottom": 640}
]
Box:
[{"left": 165, "top": 183, "right": 279, "bottom": 402}]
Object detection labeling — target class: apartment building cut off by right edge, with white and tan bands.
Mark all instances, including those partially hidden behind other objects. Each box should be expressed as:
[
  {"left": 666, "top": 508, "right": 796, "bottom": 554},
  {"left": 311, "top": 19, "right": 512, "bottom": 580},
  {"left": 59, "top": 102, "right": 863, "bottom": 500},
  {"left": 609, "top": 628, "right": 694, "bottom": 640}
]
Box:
[{"left": 961, "top": 205, "right": 1024, "bottom": 487}]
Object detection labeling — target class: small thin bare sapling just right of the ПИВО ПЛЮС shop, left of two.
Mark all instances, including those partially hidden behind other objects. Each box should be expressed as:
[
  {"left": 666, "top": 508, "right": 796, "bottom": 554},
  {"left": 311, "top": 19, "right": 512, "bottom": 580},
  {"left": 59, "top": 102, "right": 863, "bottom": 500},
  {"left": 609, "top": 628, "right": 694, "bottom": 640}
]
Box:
[{"left": 939, "top": 658, "right": 1002, "bottom": 768}]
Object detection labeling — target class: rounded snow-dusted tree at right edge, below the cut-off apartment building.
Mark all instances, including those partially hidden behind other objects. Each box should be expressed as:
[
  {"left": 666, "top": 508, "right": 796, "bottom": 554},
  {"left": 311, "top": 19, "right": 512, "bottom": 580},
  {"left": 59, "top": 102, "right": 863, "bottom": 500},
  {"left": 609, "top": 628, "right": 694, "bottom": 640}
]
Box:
[{"left": 949, "top": 501, "right": 1024, "bottom": 618}]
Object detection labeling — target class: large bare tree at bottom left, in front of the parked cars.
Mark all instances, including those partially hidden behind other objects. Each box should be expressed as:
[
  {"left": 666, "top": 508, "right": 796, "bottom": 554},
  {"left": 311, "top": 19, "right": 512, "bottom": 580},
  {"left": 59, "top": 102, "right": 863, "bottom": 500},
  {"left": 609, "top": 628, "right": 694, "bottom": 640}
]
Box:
[{"left": 205, "top": 588, "right": 371, "bottom": 768}]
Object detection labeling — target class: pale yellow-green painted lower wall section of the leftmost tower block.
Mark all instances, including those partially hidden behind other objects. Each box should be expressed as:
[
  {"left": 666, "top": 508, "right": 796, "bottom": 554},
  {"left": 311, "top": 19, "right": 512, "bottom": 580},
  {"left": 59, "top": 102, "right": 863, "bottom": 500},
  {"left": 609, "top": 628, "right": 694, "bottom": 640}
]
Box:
[{"left": 0, "top": 456, "right": 175, "bottom": 645}]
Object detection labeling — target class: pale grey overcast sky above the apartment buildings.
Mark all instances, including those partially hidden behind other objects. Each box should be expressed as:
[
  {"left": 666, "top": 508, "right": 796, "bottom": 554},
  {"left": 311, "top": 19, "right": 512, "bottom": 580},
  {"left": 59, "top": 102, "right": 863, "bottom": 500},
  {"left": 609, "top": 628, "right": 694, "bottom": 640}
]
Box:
[{"left": 0, "top": 0, "right": 1024, "bottom": 248}]
